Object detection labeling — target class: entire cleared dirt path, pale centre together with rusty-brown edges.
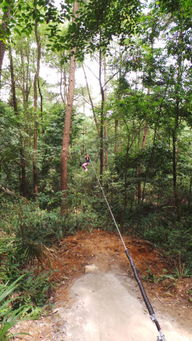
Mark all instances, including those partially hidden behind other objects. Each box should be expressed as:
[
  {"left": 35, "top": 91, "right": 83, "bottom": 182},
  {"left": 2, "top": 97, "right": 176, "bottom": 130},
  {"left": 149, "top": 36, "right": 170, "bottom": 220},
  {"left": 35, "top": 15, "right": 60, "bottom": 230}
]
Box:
[{"left": 14, "top": 230, "right": 192, "bottom": 341}]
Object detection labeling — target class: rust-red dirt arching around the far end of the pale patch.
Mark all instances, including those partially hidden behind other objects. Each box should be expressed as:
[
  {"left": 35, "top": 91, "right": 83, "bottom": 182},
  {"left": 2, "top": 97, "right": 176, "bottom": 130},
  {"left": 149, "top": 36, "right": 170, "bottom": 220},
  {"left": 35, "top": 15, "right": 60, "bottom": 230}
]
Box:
[{"left": 45, "top": 230, "right": 192, "bottom": 325}]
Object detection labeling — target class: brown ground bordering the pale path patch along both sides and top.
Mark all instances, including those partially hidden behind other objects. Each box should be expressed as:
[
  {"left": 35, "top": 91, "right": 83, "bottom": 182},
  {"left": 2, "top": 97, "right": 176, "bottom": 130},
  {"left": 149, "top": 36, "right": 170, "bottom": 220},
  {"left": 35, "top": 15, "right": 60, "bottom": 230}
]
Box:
[{"left": 12, "top": 230, "right": 192, "bottom": 341}]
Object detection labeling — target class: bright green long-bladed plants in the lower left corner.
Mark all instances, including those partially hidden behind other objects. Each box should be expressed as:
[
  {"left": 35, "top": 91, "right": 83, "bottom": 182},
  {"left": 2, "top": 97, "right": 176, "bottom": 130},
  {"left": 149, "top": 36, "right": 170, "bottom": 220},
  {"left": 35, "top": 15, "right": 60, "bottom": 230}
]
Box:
[{"left": 0, "top": 273, "right": 51, "bottom": 341}]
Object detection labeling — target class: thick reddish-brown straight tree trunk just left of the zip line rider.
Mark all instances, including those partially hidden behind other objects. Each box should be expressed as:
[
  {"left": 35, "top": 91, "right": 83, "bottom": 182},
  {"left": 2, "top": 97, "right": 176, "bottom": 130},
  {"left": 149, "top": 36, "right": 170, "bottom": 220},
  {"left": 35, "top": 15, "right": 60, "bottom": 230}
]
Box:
[{"left": 61, "top": 2, "right": 78, "bottom": 214}]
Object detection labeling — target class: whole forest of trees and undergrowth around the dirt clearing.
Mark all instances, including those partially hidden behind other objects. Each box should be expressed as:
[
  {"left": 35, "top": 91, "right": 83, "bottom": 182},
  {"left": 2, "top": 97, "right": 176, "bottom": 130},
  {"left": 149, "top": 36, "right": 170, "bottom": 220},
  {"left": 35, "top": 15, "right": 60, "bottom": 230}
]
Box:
[{"left": 0, "top": 0, "right": 192, "bottom": 340}]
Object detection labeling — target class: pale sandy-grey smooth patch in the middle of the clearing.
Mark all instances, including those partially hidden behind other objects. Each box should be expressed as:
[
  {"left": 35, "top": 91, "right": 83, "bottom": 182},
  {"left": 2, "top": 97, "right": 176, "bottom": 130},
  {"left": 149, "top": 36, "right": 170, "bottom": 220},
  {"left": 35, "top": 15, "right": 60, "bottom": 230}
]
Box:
[{"left": 62, "top": 273, "right": 192, "bottom": 341}]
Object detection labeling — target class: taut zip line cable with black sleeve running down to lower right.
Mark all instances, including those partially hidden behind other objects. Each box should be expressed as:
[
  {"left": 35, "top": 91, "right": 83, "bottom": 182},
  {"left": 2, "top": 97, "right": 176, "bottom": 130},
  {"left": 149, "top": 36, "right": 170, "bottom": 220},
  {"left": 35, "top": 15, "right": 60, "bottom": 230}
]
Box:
[{"left": 90, "top": 160, "right": 166, "bottom": 341}]
